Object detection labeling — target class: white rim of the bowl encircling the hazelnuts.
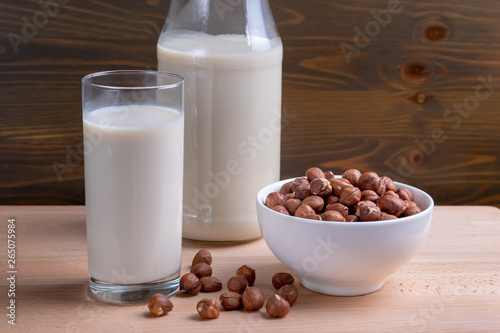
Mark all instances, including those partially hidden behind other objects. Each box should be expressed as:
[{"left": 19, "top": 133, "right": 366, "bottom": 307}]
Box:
[{"left": 256, "top": 176, "right": 434, "bottom": 226}]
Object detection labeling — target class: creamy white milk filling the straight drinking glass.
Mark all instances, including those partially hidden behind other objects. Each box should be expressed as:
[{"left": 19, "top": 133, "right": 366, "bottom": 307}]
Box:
[{"left": 83, "top": 105, "right": 184, "bottom": 284}]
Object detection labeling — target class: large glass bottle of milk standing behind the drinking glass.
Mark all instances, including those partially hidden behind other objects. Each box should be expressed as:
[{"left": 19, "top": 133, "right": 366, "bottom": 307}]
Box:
[{"left": 158, "top": 0, "right": 283, "bottom": 242}]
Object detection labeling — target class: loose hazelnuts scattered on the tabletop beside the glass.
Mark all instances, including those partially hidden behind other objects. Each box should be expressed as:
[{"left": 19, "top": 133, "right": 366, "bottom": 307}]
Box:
[{"left": 148, "top": 249, "right": 299, "bottom": 319}]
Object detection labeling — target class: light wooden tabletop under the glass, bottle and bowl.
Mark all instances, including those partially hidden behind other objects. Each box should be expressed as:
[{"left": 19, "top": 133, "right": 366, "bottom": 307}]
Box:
[{"left": 0, "top": 206, "right": 500, "bottom": 332}]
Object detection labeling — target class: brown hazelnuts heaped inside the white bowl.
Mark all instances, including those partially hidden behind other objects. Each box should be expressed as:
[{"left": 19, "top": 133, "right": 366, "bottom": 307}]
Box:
[{"left": 265, "top": 167, "right": 422, "bottom": 222}]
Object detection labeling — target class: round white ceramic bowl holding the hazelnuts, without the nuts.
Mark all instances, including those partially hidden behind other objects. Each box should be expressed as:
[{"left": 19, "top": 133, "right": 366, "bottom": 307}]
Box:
[{"left": 257, "top": 178, "right": 434, "bottom": 296}]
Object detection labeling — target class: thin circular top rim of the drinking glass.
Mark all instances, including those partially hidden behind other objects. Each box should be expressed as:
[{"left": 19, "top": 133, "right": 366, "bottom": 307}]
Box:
[{"left": 82, "top": 69, "right": 184, "bottom": 90}]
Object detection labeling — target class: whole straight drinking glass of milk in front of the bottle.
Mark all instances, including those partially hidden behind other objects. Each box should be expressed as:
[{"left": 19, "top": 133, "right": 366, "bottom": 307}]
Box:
[{"left": 82, "top": 70, "right": 184, "bottom": 303}]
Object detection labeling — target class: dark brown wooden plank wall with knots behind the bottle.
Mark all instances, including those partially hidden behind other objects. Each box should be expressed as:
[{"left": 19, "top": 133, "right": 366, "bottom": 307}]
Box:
[{"left": 0, "top": 0, "right": 500, "bottom": 206}]
